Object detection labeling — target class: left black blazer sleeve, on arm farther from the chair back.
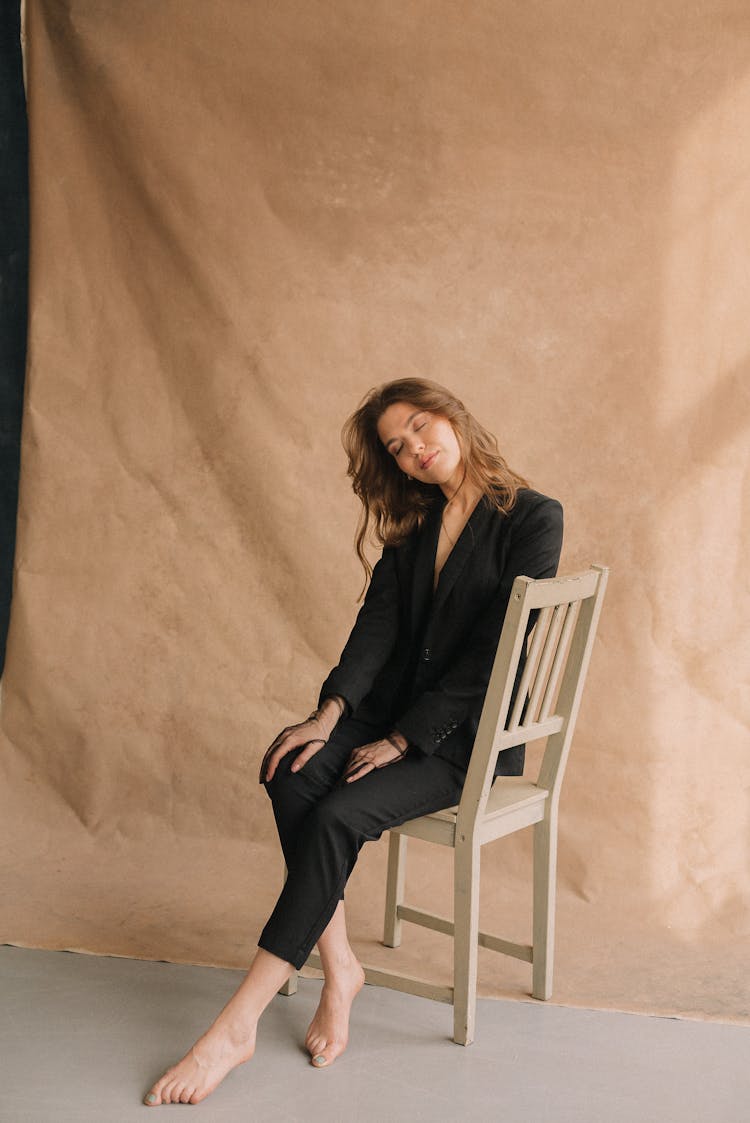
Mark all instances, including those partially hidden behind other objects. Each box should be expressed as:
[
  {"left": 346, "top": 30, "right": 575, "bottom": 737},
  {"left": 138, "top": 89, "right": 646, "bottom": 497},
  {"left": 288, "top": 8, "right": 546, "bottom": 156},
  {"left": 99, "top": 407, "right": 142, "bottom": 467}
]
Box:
[{"left": 318, "top": 546, "right": 399, "bottom": 711}]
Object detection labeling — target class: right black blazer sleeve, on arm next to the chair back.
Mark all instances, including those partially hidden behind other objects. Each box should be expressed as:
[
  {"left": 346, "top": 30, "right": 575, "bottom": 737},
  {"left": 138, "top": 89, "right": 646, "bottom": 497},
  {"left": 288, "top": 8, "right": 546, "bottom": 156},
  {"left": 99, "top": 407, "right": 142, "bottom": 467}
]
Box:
[{"left": 394, "top": 499, "right": 563, "bottom": 754}]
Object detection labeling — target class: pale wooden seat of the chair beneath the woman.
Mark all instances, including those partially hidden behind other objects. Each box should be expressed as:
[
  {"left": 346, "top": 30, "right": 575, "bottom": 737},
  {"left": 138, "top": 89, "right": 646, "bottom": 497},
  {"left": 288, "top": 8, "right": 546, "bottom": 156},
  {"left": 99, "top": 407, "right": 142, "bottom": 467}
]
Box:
[{"left": 392, "top": 776, "right": 549, "bottom": 846}]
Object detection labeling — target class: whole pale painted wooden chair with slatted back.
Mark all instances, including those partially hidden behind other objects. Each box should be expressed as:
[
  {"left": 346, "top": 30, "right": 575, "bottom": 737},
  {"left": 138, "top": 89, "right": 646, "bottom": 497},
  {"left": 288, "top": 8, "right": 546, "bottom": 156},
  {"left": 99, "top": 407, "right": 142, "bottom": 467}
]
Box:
[{"left": 283, "top": 566, "right": 609, "bottom": 1046}]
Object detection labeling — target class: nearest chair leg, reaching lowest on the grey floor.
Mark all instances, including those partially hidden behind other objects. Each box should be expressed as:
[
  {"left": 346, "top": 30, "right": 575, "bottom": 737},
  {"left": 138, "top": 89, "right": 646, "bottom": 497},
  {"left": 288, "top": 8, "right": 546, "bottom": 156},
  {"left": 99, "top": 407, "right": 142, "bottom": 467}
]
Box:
[{"left": 454, "top": 841, "right": 479, "bottom": 1046}]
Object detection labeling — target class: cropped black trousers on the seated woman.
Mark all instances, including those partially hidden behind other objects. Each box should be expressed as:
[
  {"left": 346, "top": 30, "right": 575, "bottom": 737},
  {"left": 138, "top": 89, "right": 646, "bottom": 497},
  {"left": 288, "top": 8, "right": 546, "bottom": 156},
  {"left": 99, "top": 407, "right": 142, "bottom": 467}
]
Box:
[{"left": 258, "top": 718, "right": 466, "bottom": 969}]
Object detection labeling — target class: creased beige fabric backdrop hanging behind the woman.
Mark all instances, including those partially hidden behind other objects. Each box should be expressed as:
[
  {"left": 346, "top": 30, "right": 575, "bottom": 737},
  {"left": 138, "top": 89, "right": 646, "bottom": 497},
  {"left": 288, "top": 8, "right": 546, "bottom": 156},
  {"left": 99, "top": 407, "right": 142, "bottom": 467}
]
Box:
[{"left": 0, "top": 0, "right": 750, "bottom": 1019}]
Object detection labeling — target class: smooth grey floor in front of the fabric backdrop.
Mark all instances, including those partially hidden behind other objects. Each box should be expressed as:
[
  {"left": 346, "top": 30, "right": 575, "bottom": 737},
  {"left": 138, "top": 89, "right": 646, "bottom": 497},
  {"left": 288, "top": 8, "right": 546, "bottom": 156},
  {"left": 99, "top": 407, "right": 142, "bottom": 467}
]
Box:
[{"left": 0, "top": 946, "right": 750, "bottom": 1123}]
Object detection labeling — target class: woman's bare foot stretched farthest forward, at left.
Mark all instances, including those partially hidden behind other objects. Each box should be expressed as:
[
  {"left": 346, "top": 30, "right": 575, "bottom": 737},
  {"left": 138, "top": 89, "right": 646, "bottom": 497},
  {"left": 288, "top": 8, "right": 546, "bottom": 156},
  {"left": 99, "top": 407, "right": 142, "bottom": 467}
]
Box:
[{"left": 144, "top": 1020, "right": 255, "bottom": 1107}]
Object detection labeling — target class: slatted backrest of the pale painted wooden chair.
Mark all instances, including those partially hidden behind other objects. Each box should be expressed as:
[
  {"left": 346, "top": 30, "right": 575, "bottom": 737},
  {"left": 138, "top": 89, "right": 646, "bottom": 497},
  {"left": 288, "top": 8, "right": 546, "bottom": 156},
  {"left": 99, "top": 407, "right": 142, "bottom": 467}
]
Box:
[{"left": 459, "top": 565, "right": 609, "bottom": 827}]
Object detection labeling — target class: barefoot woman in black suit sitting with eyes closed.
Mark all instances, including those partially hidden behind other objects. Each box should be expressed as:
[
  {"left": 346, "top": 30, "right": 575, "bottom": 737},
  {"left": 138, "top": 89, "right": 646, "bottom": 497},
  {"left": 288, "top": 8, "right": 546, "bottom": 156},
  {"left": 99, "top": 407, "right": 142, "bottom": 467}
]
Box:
[{"left": 146, "top": 378, "right": 563, "bottom": 1106}]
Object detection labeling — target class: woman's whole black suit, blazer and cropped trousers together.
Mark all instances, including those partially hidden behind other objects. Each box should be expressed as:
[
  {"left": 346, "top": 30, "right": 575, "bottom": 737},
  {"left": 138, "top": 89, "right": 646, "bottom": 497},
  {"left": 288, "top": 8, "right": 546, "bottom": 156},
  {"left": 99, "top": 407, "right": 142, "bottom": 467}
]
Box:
[{"left": 258, "top": 489, "right": 563, "bottom": 967}]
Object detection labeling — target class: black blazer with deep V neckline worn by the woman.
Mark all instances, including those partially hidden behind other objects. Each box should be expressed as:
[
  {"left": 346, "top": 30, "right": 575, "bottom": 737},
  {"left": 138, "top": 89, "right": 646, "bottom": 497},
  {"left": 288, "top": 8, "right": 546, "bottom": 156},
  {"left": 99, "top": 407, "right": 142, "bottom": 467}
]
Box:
[{"left": 320, "top": 489, "right": 563, "bottom": 776}]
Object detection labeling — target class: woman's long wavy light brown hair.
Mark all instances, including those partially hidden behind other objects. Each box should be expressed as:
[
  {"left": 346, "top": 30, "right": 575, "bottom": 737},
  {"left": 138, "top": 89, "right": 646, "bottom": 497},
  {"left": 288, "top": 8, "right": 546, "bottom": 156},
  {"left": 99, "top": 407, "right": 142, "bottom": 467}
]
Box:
[{"left": 341, "top": 378, "right": 529, "bottom": 585}]
